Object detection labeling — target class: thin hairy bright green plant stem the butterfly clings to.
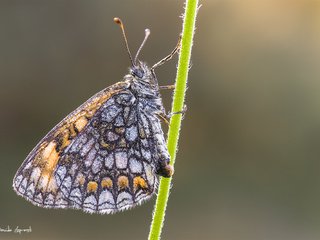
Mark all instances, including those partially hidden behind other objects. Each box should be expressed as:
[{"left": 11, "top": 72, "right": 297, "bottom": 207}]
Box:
[{"left": 149, "top": 0, "right": 198, "bottom": 240}]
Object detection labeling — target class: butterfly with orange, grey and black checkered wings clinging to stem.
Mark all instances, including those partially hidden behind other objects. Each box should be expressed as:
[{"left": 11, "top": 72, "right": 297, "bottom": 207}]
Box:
[{"left": 13, "top": 18, "right": 180, "bottom": 214}]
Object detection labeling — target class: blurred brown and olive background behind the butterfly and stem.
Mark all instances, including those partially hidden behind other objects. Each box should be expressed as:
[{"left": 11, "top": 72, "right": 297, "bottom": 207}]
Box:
[{"left": 0, "top": 0, "right": 320, "bottom": 240}]
